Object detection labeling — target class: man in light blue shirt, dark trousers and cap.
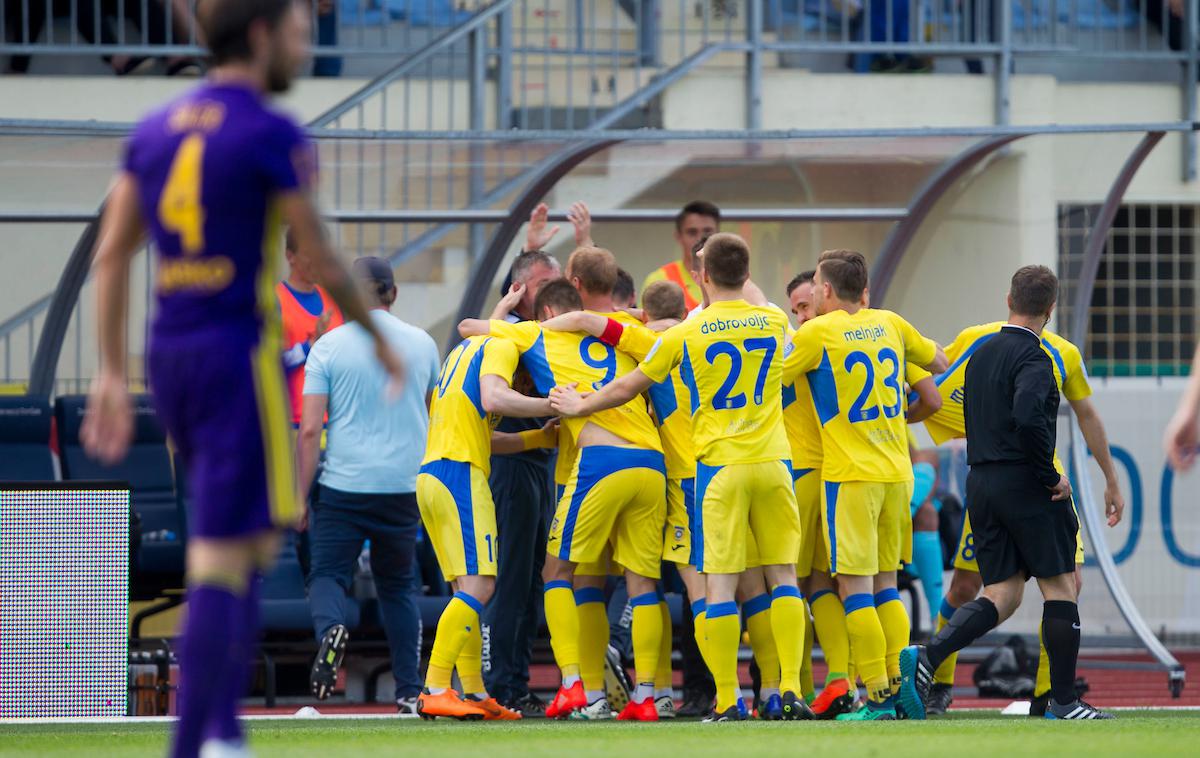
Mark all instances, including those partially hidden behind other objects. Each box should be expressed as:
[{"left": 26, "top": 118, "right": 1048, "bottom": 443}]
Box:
[{"left": 296, "top": 258, "right": 439, "bottom": 714}]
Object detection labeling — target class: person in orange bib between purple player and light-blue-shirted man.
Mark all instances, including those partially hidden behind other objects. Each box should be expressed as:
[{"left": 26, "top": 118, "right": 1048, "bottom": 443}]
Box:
[{"left": 275, "top": 229, "right": 342, "bottom": 427}]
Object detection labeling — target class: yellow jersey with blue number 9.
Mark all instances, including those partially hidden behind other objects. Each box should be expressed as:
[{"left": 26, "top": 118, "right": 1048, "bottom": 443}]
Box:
[{"left": 488, "top": 313, "right": 662, "bottom": 455}]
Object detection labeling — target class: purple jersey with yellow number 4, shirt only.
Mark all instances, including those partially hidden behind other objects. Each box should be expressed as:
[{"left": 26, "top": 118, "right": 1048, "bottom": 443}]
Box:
[{"left": 124, "top": 84, "right": 316, "bottom": 336}]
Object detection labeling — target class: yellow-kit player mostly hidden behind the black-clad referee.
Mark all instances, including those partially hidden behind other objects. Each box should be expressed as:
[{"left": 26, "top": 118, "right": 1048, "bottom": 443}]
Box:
[{"left": 910, "top": 321, "right": 1124, "bottom": 717}]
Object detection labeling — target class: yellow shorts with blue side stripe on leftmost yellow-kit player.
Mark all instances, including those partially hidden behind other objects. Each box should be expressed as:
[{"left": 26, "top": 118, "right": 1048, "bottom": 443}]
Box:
[{"left": 416, "top": 459, "right": 496, "bottom": 582}]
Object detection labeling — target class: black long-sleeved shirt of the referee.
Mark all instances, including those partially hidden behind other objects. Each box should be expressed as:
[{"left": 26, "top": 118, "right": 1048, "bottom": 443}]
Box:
[{"left": 962, "top": 324, "right": 1058, "bottom": 487}]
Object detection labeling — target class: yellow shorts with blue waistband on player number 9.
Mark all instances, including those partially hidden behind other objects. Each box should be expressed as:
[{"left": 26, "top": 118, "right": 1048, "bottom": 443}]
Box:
[{"left": 546, "top": 445, "right": 667, "bottom": 579}]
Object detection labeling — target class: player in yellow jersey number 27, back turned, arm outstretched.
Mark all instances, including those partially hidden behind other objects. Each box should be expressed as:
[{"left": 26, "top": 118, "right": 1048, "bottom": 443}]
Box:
[{"left": 551, "top": 234, "right": 804, "bottom": 721}]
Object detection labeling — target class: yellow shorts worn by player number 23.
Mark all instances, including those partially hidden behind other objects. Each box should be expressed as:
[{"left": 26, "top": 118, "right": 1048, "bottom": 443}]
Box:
[{"left": 821, "top": 480, "right": 912, "bottom": 577}]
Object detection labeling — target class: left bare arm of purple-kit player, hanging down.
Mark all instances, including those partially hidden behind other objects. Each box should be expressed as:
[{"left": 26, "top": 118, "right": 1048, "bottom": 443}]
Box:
[{"left": 79, "top": 173, "right": 145, "bottom": 464}]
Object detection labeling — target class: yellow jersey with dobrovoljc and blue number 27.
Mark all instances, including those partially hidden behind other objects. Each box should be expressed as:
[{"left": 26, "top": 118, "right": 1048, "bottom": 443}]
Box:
[{"left": 641, "top": 300, "right": 791, "bottom": 465}]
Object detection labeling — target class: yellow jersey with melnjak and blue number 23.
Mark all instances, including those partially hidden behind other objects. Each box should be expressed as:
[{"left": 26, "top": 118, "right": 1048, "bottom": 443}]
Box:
[{"left": 784, "top": 308, "right": 937, "bottom": 482}]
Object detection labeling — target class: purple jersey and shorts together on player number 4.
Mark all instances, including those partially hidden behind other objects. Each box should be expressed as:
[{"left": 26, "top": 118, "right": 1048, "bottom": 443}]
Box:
[{"left": 124, "top": 84, "right": 313, "bottom": 539}]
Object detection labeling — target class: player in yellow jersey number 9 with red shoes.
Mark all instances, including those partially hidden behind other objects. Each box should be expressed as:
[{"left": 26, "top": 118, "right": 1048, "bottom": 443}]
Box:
[{"left": 460, "top": 248, "right": 666, "bottom": 721}]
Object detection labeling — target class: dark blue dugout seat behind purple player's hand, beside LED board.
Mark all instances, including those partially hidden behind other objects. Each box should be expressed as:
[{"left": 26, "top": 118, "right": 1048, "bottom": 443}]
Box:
[{"left": 54, "top": 395, "right": 184, "bottom": 598}]
